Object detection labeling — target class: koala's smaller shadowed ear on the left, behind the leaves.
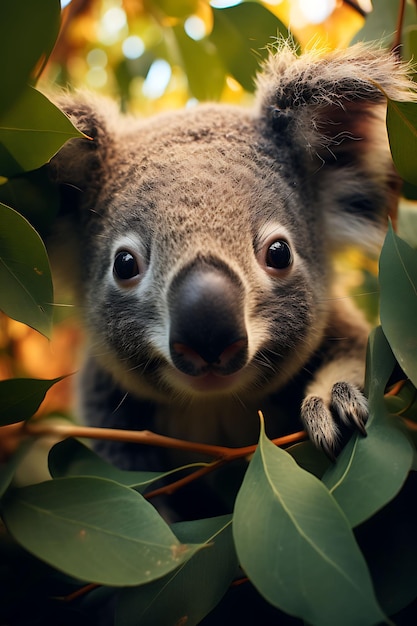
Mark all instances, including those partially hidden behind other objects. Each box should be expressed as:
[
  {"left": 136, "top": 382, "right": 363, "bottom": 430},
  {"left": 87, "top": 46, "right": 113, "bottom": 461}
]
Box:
[{"left": 46, "top": 93, "right": 118, "bottom": 294}]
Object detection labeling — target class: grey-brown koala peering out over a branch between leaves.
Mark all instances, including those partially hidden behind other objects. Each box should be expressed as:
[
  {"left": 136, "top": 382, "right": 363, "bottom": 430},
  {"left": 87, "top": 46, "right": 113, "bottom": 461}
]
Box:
[{"left": 49, "top": 43, "right": 410, "bottom": 488}]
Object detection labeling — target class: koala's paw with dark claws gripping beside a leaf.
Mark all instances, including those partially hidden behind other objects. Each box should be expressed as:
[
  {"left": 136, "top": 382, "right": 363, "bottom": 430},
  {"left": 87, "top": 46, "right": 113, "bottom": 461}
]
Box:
[{"left": 301, "top": 382, "right": 368, "bottom": 460}]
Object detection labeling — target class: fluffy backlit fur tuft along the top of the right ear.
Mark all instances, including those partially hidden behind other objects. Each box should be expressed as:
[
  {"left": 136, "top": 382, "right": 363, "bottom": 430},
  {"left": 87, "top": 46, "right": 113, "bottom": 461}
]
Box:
[{"left": 257, "top": 42, "right": 417, "bottom": 152}]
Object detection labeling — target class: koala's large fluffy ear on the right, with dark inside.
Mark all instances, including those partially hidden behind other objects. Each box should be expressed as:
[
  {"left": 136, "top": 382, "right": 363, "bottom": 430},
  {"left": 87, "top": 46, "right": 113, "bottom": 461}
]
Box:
[{"left": 257, "top": 44, "right": 416, "bottom": 248}]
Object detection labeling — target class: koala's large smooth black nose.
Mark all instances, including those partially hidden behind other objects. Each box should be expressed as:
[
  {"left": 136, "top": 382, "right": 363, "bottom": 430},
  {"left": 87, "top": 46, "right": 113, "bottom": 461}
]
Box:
[{"left": 168, "top": 265, "right": 248, "bottom": 376}]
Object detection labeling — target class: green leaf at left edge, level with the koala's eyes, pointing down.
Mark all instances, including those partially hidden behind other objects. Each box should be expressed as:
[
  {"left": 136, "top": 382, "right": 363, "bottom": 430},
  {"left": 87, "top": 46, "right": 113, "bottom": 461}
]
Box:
[{"left": 0, "top": 204, "right": 53, "bottom": 337}]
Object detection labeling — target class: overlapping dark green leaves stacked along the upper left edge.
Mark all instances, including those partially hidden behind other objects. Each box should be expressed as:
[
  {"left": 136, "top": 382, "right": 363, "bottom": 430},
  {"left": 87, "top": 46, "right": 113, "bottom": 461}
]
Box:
[{"left": 0, "top": 0, "right": 80, "bottom": 336}]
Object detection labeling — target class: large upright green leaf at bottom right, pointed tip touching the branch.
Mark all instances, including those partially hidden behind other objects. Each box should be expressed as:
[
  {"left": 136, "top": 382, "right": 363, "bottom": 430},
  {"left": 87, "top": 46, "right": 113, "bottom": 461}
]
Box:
[{"left": 233, "top": 420, "right": 385, "bottom": 626}]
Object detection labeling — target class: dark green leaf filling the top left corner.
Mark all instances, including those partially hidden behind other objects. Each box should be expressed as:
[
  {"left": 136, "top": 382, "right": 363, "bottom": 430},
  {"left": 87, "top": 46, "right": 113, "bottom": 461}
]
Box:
[{"left": 0, "top": 0, "right": 61, "bottom": 116}]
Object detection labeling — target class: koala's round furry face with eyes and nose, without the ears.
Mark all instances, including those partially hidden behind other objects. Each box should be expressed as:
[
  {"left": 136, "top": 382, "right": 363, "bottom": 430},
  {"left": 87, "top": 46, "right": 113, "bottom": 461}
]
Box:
[{"left": 81, "top": 107, "right": 328, "bottom": 401}]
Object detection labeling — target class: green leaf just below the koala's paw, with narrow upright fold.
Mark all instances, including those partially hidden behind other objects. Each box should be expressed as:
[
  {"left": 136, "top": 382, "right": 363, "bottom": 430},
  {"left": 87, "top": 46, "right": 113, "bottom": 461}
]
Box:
[{"left": 323, "top": 328, "right": 413, "bottom": 526}]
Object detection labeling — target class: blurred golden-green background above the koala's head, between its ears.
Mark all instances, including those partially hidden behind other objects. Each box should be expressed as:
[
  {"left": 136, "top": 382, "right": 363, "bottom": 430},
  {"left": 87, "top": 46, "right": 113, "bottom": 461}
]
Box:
[{"left": 45, "top": 0, "right": 370, "bottom": 114}]
